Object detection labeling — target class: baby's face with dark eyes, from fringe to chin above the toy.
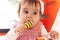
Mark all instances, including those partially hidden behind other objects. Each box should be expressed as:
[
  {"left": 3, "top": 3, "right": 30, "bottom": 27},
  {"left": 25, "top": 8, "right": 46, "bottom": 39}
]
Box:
[{"left": 19, "top": 2, "right": 40, "bottom": 26}]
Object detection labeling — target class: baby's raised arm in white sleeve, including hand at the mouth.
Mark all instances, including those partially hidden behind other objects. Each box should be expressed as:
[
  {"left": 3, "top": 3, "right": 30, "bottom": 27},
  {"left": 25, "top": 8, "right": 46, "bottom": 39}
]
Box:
[{"left": 5, "top": 24, "right": 24, "bottom": 40}]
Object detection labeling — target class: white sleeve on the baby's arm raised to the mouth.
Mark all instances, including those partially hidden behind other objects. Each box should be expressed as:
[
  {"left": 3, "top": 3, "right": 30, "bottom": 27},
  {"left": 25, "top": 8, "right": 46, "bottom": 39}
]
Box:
[{"left": 4, "top": 28, "right": 18, "bottom": 40}]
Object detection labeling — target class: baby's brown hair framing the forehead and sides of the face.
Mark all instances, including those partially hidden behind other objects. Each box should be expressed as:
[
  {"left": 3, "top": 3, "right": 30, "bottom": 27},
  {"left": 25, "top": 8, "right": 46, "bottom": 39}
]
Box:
[{"left": 18, "top": 0, "right": 44, "bottom": 15}]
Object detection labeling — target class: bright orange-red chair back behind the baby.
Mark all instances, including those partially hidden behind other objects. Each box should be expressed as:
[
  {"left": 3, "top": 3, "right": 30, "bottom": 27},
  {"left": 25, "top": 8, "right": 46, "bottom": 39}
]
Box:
[{"left": 42, "top": 0, "right": 60, "bottom": 32}]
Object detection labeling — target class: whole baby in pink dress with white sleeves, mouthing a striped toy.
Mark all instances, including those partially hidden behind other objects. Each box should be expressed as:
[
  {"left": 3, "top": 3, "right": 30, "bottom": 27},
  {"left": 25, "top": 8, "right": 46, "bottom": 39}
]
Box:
[{"left": 5, "top": 0, "right": 59, "bottom": 40}]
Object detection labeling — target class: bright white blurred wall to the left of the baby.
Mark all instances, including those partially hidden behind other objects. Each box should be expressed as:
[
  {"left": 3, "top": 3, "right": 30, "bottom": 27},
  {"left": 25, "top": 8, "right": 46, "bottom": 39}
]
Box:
[{"left": 0, "top": 0, "right": 18, "bottom": 29}]
